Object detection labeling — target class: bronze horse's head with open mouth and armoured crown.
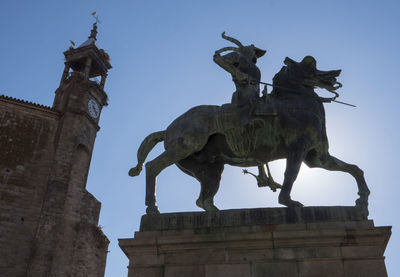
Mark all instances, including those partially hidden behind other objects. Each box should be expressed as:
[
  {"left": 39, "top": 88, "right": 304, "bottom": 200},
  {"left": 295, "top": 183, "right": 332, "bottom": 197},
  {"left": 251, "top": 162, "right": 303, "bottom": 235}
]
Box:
[{"left": 280, "top": 56, "right": 342, "bottom": 93}]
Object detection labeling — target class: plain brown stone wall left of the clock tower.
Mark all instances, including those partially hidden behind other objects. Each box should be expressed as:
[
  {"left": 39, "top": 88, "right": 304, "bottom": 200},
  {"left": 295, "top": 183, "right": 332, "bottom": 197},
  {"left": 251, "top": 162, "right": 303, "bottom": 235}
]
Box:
[{"left": 0, "top": 99, "right": 58, "bottom": 277}]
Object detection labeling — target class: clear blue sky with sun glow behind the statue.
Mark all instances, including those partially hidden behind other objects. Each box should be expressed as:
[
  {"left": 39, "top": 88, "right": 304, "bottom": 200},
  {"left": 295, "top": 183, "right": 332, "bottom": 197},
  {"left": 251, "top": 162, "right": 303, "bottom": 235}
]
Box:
[{"left": 0, "top": 0, "right": 400, "bottom": 277}]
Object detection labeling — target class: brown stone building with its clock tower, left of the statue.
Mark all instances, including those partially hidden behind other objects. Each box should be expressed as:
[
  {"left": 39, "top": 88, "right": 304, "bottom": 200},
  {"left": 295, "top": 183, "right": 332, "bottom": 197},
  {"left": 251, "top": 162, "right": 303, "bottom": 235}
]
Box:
[{"left": 0, "top": 23, "right": 111, "bottom": 277}]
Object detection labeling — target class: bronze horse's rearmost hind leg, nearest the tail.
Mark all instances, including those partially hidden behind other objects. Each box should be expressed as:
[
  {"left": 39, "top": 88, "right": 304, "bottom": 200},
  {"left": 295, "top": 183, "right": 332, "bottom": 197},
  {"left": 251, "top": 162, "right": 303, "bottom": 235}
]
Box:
[{"left": 146, "top": 144, "right": 192, "bottom": 214}]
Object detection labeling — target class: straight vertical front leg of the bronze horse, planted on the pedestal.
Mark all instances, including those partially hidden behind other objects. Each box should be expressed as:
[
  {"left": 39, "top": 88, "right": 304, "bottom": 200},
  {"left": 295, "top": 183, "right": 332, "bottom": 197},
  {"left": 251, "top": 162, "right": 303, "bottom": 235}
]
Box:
[{"left": 279, "top": 151, "right": 303, "bottom": 207}]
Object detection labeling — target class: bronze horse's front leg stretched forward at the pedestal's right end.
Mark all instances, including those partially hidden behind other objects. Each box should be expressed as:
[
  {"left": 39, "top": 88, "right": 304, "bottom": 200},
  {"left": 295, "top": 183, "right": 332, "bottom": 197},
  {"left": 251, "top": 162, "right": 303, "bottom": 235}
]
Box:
[{"left": 304, "top": 154, "right": 370, "bottom": 215}]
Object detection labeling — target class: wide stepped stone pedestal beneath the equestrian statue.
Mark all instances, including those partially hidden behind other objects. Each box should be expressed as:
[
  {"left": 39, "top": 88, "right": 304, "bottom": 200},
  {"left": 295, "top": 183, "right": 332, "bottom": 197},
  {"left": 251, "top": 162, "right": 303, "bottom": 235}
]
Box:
[{"left": 119, "top": 207, "right": 391, "bottom": 277}]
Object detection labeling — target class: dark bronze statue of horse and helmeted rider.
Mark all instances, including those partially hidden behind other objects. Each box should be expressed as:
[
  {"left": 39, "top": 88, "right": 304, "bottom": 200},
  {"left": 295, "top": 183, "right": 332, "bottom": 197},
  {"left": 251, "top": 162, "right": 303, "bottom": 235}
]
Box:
[{"left": 129, "top": 33, "right": 369, "bottom": 213}]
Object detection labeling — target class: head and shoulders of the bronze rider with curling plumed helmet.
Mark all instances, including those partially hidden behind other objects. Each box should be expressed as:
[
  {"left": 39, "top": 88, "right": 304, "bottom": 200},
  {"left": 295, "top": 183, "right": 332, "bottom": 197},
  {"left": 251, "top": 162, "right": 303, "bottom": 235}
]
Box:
[{"left": 214, "top": 32, "right": 266, "bottom": 84}]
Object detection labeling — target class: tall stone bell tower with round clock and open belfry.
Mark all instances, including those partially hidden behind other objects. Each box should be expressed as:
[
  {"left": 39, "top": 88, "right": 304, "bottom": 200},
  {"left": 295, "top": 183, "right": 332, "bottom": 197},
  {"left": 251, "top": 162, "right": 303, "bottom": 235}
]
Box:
[{"left": 27, "top": 18, "right": 111, "bottom": 277}]
